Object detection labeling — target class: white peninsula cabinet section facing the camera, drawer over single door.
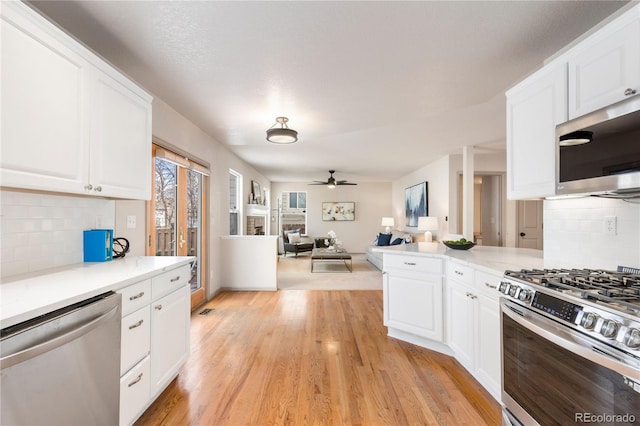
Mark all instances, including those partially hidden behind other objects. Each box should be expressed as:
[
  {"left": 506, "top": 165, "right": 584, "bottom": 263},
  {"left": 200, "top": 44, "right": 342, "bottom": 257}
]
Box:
[{"left": 383, "top": 253, "right": 444, "bottom": 342}]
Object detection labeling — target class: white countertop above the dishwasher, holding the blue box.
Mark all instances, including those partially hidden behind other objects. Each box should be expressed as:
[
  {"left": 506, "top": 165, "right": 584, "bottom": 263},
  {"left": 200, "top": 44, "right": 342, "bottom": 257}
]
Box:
[{"left": 0, "top": 256, "right": 195, "bottom": 328}]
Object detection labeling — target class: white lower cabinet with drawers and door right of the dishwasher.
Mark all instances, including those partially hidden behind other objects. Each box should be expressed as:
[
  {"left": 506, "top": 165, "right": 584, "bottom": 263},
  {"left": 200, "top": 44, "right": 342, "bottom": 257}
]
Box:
[{"left": 118, "top": 265, "right": 191, "bottom": 425}]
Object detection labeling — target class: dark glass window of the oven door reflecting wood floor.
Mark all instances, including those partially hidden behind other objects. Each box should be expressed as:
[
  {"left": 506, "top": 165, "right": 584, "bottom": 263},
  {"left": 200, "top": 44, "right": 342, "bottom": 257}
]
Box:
[{"left": 502, "top": 314, "right": 640, "bottom": 425}]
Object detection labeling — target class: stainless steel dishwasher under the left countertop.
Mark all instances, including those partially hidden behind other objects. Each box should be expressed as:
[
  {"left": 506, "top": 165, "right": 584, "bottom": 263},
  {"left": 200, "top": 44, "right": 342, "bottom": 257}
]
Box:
[{"left": 0, "top": 292, "right": 121, "bottom": 425}]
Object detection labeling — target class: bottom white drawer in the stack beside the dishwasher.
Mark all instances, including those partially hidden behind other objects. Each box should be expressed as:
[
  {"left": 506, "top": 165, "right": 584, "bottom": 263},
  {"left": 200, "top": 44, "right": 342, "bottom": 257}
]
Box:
[{"left": 120, "top": 356, "right": 151, "bottom": 425}]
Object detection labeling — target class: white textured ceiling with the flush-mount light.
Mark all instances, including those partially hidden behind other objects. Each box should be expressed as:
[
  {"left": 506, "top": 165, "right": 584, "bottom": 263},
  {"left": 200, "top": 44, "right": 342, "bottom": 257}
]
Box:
[{"left": 32, "top": 1, "right": 626, "bottom": 182}]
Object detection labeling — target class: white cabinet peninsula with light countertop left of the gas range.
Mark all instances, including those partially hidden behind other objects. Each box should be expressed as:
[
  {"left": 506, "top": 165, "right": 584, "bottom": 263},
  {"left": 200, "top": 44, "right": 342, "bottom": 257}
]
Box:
[{"left": 374, "top": 243, "right": 566, "bottom": 401}]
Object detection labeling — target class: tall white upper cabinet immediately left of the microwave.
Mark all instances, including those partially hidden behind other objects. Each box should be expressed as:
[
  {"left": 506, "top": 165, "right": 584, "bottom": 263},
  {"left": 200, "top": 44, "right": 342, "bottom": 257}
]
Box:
[{"left": 507, "top": 63, "right": 567, "bottom": 199}]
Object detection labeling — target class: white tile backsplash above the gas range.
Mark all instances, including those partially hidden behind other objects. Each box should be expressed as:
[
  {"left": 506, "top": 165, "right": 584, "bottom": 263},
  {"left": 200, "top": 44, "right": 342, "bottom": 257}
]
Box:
[{"left": 544, "top": 197, "right": 640, "bottom": 270}]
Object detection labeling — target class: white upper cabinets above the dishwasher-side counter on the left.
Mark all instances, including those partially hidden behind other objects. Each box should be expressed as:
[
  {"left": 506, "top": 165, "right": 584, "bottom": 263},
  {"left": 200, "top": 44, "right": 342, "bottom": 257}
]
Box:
[{"left": 0, "top": 2, "right": 151, "bottom": 199}]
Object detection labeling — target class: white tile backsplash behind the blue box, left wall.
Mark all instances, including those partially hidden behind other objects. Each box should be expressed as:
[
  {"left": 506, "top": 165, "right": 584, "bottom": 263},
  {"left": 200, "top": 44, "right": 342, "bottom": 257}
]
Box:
[{"left": 0, "top": 190, "right": 115, "bottom": 278}]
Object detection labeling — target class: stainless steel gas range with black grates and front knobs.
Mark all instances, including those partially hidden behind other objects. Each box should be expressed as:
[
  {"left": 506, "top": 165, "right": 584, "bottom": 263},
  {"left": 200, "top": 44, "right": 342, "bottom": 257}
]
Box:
[{"left": 498, "top": 269, "right": 640, "bottom": 425}]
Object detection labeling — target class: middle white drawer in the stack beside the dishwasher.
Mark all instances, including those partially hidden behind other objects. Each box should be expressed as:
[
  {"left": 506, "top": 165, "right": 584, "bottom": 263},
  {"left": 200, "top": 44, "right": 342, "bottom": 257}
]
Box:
[{"left": 120, "top": 305, "right": 151, "bottom": 375}]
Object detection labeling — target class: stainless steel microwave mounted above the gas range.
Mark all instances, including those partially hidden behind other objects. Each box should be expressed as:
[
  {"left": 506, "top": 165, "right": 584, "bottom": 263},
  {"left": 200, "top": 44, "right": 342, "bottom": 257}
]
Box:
[{"left": 556, "top": 95, "right": 640, "bottom": 197}]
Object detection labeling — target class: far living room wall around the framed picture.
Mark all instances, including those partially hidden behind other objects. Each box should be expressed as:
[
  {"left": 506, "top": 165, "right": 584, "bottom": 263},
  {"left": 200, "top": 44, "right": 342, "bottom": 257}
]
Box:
[{"left": 271, "top": 182, "right": 390, "bottom": 253}]
